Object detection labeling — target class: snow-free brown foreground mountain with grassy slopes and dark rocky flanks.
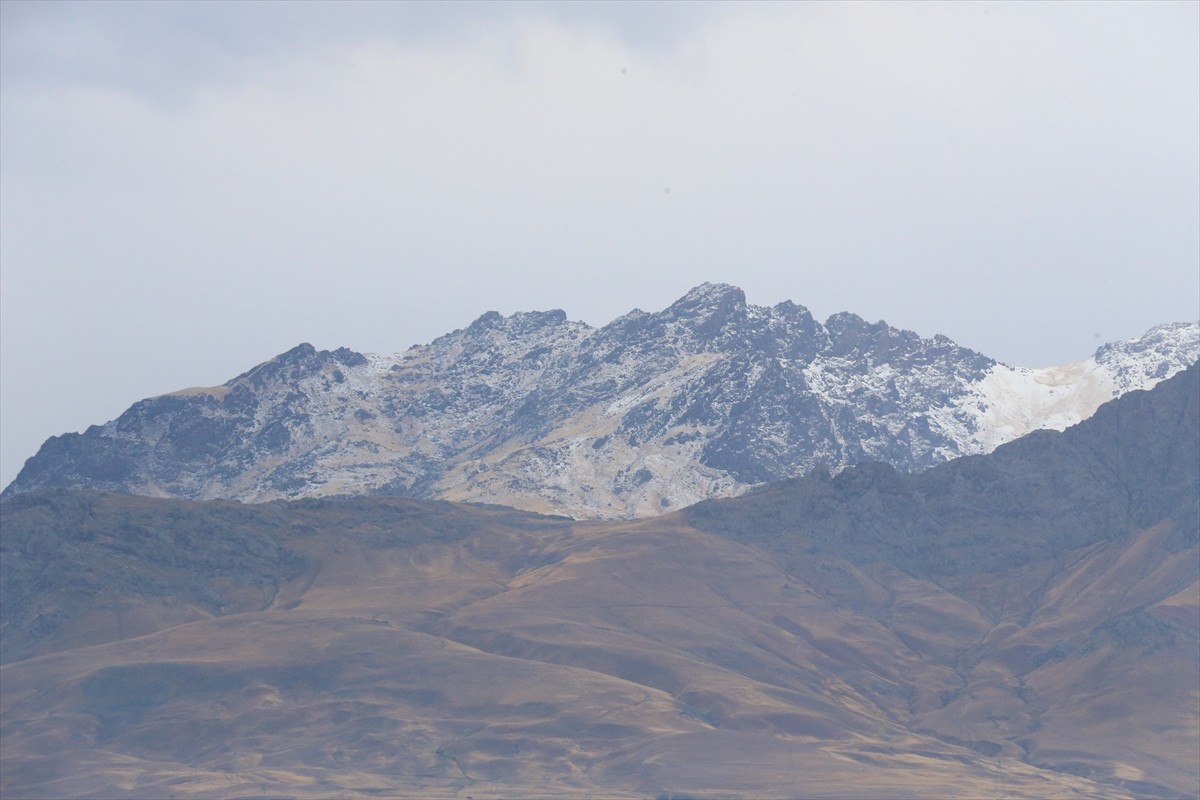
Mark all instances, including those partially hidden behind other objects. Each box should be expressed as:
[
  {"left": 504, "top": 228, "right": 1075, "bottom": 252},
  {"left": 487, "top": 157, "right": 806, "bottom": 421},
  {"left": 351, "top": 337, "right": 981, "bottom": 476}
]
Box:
[{"left": 0, "top": 366, "right": 1200, "bottom": 799}]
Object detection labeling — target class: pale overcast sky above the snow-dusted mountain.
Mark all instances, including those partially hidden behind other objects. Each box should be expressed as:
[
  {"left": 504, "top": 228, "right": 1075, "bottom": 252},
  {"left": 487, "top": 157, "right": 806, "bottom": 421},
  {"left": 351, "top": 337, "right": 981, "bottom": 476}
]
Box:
[{"left": 0, "top": 0, "right": 1200, "bottom": 485}]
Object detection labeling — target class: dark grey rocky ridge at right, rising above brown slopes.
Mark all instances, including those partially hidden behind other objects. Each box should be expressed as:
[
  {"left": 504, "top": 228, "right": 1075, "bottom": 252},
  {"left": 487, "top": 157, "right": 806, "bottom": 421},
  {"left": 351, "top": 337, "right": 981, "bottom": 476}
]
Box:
[{"left": 688, "top": 365, "right": 1200, "bottom": 585}]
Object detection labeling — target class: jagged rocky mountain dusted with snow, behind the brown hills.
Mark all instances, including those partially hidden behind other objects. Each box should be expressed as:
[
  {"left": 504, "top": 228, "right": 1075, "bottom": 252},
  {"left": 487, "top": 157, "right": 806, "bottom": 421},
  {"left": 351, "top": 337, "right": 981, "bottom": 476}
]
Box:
[{"left": 4, "top": 283, "right": 1200, "bottom": 518}]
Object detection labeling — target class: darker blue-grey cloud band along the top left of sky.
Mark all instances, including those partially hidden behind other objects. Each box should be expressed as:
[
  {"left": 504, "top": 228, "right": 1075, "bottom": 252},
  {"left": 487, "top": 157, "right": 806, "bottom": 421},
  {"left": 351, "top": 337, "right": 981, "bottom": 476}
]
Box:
[{"left": 0, "top": 0, "right": 710, "bottom": 103}]
